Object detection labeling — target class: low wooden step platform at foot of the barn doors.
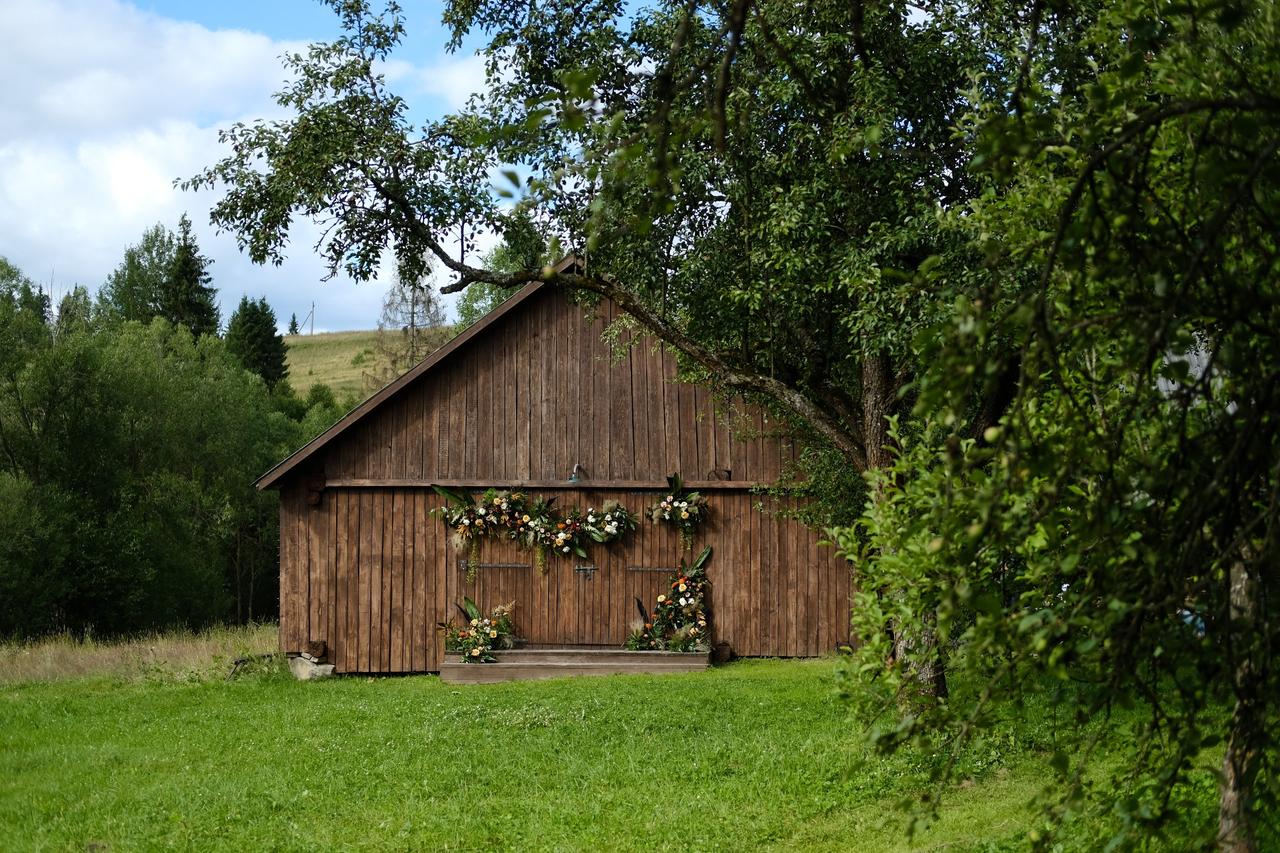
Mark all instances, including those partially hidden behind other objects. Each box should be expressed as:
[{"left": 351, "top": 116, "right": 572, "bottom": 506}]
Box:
[{"left": 440, "top": 648, "right": 710, "bottom": 684}]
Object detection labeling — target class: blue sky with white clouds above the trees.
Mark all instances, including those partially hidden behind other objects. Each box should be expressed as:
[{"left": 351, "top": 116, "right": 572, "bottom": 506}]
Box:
[{"left": 0, "top": 0, "right": 494, "bottom": 332}]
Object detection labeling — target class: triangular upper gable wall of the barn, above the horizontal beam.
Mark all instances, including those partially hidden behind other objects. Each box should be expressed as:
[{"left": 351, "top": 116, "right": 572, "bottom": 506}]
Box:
[{"left": 325, "top": 288, "right": 794, "bottom": 485}]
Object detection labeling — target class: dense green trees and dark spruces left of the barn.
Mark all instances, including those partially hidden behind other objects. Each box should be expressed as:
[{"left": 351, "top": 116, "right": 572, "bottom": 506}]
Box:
[{"left": 0, "top": 222, "right": 351, "bottom": 637}]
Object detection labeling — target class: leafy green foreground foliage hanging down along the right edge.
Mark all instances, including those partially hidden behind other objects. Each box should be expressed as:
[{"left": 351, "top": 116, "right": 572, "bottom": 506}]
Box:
[{"left": 837, "top": 3, "right": 1280, "bottom": 848}]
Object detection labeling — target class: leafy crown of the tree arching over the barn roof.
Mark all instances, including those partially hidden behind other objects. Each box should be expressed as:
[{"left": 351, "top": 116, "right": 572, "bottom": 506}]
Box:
[{"left": 187, "top": 0, "right": 988, "bottom": 491}]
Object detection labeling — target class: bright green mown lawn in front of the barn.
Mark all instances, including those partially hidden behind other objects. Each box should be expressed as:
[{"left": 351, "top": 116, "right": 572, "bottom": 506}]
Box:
[{"left": 0, "top": 648, "right": 1218, "bottom": 850}]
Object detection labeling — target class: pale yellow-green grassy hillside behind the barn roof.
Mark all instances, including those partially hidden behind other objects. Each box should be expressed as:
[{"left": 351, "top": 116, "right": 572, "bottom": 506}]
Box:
[{"left": 284, "top": 328, "right": 452, "bottom": 400}]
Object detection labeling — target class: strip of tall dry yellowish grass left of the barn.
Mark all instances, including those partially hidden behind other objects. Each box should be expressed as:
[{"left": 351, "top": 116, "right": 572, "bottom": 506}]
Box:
[{"left": 0, "top": 624, "right": 279, "bottom": 684}]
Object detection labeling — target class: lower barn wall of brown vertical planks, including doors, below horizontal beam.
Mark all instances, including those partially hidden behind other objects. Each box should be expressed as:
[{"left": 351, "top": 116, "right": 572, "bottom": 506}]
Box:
[{"left": 280, "top": 487, "right": 850, "bottom": 672}]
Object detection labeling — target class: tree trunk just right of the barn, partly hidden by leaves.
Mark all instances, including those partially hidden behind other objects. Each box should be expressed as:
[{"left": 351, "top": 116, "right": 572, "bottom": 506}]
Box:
[{"left": 863, "top": 353, "right": 947, "bottom": 701}]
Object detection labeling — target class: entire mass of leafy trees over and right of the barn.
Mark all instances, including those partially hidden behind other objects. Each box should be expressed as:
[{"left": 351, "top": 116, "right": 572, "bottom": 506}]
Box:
[{"left": 187, "top": 0, "right": 1280, "bottom": 850}]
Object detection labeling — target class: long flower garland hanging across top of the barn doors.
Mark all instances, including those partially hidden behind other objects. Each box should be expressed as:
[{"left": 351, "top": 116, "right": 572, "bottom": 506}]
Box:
[{"left": 431, "top": 485, "right": 636, "bottom": 583}]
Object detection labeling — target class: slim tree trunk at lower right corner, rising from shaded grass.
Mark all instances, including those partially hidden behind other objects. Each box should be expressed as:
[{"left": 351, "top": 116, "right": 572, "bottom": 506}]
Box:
[{"left": 1217, "top": 561, "right": 1263, "bottom": 853}]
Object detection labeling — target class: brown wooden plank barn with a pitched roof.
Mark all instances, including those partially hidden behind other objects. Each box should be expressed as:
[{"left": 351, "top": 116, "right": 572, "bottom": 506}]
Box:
[{"left": 259, "top": 266, "right": 850, "bottom": 672}]
